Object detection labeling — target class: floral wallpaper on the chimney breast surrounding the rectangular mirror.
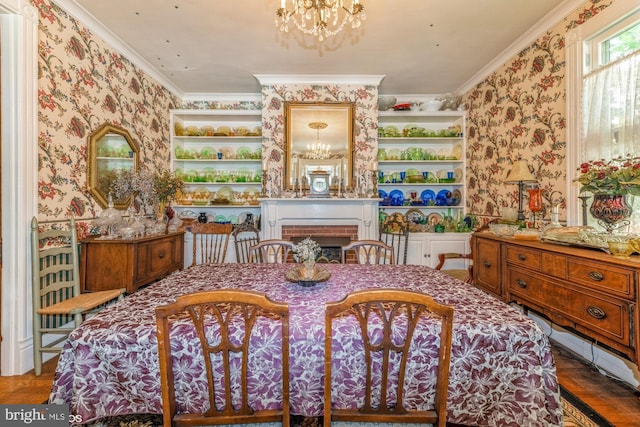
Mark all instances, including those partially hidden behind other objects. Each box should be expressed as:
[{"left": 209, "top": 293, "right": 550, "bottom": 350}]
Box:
[{"left": 262, "top": 84, "right": 378, "bottom": 194}]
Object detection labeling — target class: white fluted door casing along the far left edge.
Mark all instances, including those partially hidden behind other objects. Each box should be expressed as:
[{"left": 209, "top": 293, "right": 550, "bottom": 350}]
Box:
[{"left": 0, "top": 0, "right": 38, "bottom": 375}]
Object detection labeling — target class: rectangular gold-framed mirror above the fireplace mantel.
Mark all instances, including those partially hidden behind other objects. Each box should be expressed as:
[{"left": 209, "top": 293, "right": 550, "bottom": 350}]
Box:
[{"left": 283, "top": 102, "right": 355, "bottom": 190}]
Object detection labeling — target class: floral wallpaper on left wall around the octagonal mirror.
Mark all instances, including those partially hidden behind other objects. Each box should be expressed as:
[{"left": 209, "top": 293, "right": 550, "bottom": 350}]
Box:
[{"left": 32, "top": 0, "right": 179, "bottom": 227}]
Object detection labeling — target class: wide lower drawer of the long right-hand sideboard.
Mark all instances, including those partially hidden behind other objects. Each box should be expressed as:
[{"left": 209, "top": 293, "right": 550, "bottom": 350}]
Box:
[{"left": 507, "top": 268, "right": 633, "bottom": 346}]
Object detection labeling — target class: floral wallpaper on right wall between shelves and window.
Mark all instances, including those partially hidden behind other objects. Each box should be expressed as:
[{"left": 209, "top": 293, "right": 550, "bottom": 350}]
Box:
[{"left": 463, "top": 0, "right": 613, "bottom": 226}]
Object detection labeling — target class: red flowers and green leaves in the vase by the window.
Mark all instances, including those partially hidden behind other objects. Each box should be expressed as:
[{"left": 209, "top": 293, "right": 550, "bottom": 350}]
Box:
[{"left": 577, "top": 155, "right": 640, "bottom": 196}]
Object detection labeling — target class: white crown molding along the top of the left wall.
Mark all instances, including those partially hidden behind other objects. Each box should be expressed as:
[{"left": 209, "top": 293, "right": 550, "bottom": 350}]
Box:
[{"left": 54, "top": 0, "right": 184, "bottom": 99}]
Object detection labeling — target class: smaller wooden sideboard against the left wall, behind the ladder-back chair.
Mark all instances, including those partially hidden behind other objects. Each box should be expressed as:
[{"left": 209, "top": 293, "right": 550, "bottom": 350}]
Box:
[{"left": 80, "top": 231, "right": 184, "bottom": 293}]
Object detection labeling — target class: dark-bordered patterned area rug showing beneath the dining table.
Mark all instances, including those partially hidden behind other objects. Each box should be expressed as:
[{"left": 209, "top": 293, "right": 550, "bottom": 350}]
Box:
[{"left": 82, "top": 392, "right": 614, "bottom": 427}]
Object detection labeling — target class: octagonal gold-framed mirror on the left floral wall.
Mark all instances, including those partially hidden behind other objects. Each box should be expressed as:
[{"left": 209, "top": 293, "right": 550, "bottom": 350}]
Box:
[{"left": 87, "top": 123, "right": 140, "bottom": 209}]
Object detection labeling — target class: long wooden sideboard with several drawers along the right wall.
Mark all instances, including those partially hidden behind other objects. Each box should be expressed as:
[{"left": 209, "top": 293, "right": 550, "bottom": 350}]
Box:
[{"left": 471, "top": 231, "right": 640, "bottom": 368}]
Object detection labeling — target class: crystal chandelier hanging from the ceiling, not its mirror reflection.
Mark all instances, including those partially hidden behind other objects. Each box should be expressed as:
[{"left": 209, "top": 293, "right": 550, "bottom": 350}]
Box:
[{"left": 276, "top": 0, "right": 366, "bottom": 41}]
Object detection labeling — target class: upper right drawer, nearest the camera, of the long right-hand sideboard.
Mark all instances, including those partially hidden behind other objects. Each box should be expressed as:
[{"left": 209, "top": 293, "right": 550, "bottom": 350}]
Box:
[{"left": 567, "top": 258, "right": 635, "bottom": 299}]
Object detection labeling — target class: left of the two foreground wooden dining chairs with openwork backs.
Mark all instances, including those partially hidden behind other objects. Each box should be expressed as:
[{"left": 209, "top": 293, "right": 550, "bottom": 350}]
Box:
[{"left": 155, "top": 290, "right": 289, "bottom": 427}]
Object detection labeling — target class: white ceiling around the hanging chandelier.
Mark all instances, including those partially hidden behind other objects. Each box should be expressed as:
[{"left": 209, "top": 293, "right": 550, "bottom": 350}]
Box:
[{"left": 58, "top": 0, "right": 582, "bottom": 95}]
